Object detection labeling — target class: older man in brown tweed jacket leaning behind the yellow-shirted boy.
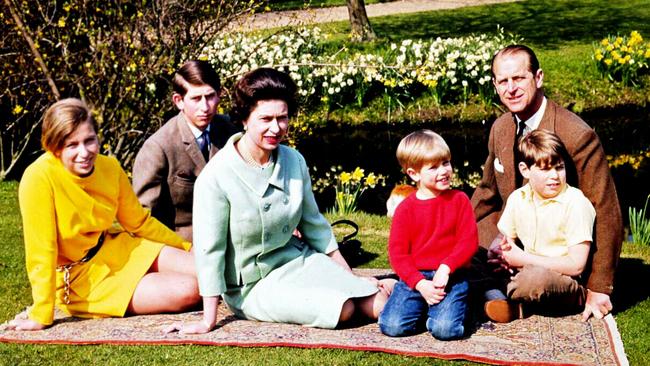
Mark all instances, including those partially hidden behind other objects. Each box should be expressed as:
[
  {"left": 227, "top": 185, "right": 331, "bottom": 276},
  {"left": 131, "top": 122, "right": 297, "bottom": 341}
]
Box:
[{"left": 472, "top": 45, "right": 623, "bottom": 320}]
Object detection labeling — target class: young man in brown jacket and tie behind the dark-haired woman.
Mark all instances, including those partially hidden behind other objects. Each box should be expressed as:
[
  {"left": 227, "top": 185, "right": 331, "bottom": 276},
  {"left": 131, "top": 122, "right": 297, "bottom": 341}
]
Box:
[{"left": 133, "top": 61, "right": 238, "bottom": 241}]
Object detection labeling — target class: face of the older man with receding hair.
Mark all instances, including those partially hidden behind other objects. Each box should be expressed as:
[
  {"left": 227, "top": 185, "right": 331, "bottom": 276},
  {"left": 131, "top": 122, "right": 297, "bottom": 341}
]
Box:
[{"left": 492, "top": 52, "right": 544, "bottom": 121}]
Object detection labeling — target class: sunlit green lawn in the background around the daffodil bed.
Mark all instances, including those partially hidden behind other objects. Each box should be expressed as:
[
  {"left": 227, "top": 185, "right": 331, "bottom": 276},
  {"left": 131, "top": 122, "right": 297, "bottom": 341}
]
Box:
[{"left": 288, "top": 0, "right": 650, "bottom": 123}]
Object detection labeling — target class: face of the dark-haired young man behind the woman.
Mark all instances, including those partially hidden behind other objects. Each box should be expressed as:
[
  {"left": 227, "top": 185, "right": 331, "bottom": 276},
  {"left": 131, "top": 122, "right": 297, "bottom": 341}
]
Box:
[{"left": 172, "top": 84, "right": 219, "bottom": 131}]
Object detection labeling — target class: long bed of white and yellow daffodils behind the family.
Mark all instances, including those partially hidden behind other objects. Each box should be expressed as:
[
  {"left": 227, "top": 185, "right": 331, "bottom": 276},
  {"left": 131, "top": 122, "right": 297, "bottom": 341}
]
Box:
[{"left": 204, "top": 28, "right": 520, "bottom": 118}]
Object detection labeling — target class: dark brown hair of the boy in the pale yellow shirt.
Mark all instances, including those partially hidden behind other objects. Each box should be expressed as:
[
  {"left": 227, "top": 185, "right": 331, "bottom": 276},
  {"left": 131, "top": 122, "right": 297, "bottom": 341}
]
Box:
[{"left": 517, "top": 129, "right": 569, "bottom": 169}]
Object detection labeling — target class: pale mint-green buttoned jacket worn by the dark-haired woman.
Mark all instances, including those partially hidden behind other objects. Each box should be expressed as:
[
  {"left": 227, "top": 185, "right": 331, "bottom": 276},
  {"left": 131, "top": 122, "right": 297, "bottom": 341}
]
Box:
[{"left": 193, "top": 134, "right": 338, "bottom": 296}]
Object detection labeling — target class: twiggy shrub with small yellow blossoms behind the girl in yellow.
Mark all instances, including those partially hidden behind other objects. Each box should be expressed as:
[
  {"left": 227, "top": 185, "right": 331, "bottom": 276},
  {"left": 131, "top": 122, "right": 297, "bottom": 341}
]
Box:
[{"left": 0, "top": 0, "right": 263, "bottom": 180}]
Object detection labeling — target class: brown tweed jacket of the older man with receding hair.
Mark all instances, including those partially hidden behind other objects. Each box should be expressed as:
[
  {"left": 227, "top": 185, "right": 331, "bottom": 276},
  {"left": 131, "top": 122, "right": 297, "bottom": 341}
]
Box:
[{"left": 472, "top": 100, "right": 623, "bottom": 294}]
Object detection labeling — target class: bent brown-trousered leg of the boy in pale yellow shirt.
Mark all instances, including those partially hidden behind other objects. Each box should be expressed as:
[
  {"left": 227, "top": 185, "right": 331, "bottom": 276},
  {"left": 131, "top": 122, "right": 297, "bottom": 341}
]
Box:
[{"left": 507, "top": 265, "right": 586, "bottom": 314}]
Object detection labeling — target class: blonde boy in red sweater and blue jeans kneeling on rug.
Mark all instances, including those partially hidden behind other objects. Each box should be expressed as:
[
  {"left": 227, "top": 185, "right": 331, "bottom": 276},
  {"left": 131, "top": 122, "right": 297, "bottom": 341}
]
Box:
[{"left": 379, "top": 130, "right": 478, "bottom": 340}]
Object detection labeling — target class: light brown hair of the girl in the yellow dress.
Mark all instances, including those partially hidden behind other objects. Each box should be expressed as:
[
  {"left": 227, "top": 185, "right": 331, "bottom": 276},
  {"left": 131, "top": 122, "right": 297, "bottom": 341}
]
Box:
[{"left": 41, "top": 98, "right": 97, "bottom": 153}]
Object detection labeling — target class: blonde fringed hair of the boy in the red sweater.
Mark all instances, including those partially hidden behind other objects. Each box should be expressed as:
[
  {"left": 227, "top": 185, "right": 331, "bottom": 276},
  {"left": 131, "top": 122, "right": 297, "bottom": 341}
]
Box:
[{"left": 396, "top": 130, "right": 451, "bottom": 172}]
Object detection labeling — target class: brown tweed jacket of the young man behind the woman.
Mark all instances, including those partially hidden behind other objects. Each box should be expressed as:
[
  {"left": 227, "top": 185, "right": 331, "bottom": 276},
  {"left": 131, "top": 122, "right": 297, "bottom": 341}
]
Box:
[{"left": 133, "top": 112, "right": 238, "bottom": 241}]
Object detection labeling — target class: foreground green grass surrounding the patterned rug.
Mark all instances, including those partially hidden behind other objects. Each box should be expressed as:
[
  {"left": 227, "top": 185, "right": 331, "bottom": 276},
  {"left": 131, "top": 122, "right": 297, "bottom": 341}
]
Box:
[{"left": 0, "top": 182, "right": 650, "bottom": 366}]
